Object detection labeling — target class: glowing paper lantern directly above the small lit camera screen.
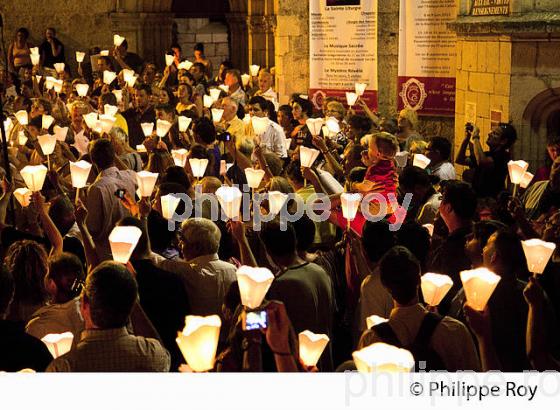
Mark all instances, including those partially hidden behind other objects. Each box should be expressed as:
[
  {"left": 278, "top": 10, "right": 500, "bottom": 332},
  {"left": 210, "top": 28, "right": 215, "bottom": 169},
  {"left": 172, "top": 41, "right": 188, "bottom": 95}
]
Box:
[{"left": 237, "top": 266, "right": 274, "bottom": 309}]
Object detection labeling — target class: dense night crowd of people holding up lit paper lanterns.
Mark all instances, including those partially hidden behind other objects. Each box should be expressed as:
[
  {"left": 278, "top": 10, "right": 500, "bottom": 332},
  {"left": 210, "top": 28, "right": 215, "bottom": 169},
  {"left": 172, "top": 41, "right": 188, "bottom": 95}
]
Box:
[{"left": 0, "top": 24, "right": 560, "bottom": 372}]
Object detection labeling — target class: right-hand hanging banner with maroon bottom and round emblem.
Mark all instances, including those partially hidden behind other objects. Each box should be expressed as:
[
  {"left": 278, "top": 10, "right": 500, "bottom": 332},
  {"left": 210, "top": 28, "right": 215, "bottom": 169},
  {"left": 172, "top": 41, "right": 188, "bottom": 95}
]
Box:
[{"left": 395, "top": 0, "right": 457, "bottom": 116}]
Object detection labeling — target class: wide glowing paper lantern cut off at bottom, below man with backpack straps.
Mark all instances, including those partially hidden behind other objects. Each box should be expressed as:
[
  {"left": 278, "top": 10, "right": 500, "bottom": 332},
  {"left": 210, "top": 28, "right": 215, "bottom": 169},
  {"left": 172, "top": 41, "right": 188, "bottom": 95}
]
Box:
[{"left": 352, "top": 343, "right": 414, "bottom": 373}]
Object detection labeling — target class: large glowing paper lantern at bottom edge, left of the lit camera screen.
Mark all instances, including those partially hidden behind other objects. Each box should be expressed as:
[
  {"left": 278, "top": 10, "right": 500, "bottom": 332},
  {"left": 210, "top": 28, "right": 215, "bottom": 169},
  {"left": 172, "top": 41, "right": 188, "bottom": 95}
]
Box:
[{"left": 176, "top": 315, "right": 222, "bottom": 372}]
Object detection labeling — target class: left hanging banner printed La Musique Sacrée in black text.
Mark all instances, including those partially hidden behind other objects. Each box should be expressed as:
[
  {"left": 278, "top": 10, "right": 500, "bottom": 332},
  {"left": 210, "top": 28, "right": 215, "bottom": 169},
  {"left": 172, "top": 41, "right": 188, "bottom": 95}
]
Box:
[{"left": 309, "top": 0, "right": 377, "bottom": 110}]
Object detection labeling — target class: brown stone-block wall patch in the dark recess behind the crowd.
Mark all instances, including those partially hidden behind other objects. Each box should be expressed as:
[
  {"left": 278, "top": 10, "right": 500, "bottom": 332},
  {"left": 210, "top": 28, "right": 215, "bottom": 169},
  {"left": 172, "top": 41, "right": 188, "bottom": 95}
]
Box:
[{"left": 175, "top": 18, "right": 230, "bottom": 75}]
